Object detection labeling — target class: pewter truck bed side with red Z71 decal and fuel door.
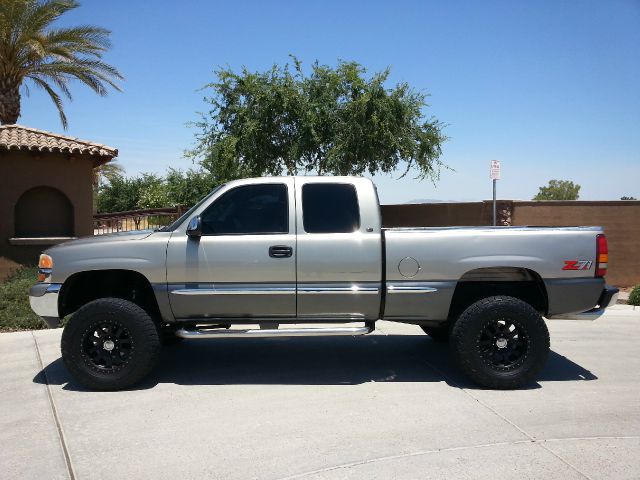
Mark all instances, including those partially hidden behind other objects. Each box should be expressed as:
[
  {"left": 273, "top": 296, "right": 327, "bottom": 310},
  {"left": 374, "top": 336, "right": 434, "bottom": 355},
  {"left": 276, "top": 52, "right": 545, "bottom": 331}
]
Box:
[{"left": 383, "top": 226, "right": 604, "bottom": 322}]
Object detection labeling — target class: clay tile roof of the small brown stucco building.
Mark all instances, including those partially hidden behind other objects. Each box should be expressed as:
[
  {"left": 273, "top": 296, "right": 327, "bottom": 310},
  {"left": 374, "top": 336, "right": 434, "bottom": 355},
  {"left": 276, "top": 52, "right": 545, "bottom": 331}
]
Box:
[{"left": 0, "top": 125, "right": 118, "bottom": 159}]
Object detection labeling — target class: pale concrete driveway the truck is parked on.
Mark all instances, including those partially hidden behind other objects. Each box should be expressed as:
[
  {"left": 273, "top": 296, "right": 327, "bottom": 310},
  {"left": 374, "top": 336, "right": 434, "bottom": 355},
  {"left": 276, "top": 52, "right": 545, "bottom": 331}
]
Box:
[{"left": 0, "top": 307, "right": 640, "bottom": 480}]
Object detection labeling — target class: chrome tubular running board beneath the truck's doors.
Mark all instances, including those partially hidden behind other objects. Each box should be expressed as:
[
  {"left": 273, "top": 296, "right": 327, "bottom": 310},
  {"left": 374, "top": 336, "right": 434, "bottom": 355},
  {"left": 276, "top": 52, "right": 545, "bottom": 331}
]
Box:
[{"left": 176, "top": 325, "right": 374, "bottom": 339}]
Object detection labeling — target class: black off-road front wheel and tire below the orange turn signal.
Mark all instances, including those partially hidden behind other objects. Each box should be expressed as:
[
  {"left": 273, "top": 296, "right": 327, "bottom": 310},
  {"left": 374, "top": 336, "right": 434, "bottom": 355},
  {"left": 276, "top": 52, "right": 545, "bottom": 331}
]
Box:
[{"left": 60, "top": 298, "right": 160, "bottom": 390}]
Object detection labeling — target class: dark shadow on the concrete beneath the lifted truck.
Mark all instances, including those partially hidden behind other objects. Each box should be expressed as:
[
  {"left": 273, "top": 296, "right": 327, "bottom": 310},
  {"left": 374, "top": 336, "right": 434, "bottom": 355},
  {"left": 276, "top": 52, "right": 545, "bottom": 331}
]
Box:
[{"left": 33, "top": 335, "right": 598, "bottom": 391}]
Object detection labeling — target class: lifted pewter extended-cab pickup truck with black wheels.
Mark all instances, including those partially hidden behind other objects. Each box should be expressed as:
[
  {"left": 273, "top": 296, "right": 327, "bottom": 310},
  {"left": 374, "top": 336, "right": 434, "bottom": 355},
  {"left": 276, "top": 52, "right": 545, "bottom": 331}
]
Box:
[{"left": 29, "top": 176, "right": 617, "bottom": 390}]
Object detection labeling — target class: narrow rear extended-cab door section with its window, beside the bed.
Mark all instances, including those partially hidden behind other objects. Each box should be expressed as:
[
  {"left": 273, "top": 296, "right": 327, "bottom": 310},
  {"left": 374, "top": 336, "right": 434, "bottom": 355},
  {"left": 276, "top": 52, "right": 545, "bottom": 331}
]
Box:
[{"left": 295, "top": 177, "right": 382, "bottom": 321}]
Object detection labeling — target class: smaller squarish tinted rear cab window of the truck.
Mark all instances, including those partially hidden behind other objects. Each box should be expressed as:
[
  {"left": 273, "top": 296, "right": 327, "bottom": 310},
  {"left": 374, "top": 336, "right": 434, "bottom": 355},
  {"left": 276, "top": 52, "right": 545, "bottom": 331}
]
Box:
[{"left": 302, "top": 183, "right": 360, "bottom": 233}]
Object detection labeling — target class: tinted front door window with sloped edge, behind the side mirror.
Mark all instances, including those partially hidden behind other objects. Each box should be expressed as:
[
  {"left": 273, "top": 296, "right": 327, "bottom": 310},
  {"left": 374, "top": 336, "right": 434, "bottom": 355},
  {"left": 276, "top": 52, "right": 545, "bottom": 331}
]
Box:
[{"left": 201, "top": 183, "right": 289, "bottom": 235}]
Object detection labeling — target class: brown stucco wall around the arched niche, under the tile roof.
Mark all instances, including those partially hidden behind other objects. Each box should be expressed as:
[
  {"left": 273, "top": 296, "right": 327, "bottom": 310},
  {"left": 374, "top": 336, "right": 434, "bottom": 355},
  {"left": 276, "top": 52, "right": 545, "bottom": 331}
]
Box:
[{"left": 0, "top": 150, "right": 93, "bottom": 264}]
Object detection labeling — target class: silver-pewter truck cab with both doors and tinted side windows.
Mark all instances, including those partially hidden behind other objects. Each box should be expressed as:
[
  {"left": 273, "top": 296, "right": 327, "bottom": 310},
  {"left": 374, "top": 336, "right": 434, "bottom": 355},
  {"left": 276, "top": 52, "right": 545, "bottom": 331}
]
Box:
[{"left": 166, "top": 177, "right": 382, "bottom": 322}]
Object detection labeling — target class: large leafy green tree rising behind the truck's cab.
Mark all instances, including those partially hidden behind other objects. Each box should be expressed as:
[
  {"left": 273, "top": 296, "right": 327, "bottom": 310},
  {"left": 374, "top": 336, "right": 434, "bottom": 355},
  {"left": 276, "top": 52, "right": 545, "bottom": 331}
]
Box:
[{"left": 190, "top": 57, "right": 446, "bottom": 179}]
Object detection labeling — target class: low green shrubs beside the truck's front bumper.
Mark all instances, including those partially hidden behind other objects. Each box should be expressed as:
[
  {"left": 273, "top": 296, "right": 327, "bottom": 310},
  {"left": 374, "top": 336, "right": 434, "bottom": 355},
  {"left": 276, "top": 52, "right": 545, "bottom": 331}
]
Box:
[{"left": 0, "top": 267, "right": 47, "bottom": 332}]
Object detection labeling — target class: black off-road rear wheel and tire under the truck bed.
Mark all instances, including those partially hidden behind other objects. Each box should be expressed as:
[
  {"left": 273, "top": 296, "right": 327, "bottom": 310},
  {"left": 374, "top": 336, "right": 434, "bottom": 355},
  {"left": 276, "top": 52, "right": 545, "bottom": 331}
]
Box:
[{"left": 450, "top": 296, "right": 549, "bottom": 389}]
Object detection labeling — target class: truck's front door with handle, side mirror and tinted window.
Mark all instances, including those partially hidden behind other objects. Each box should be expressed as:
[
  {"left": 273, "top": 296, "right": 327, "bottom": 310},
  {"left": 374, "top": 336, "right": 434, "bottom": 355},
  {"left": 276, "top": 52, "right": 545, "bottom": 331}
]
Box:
[{"left": 167, "top": 178, "right": 297, "bottom": 319}]
